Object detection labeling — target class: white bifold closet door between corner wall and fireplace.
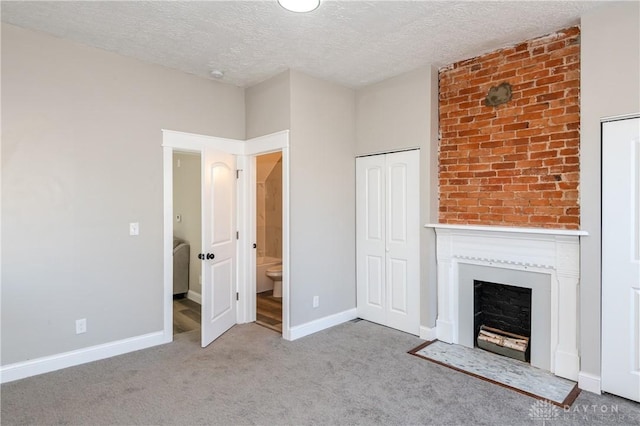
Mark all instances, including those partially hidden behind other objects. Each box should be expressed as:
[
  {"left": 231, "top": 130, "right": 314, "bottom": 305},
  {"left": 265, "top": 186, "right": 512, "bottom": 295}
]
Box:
[{"left": 356, "top": 150, "right": 420, "bottom": 335}]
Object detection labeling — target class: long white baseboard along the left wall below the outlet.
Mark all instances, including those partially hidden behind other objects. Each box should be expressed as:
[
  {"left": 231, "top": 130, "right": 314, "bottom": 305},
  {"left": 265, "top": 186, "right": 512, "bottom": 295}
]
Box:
[{"left": 0, "top": 331, "right": 173, "bottom": 383}]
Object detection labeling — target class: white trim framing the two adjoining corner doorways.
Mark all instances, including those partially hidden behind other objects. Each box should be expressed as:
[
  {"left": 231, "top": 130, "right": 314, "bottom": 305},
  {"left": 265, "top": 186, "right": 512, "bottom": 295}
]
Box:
[{"left": 162, "top": 129, "right": 291, "bottom": 343}]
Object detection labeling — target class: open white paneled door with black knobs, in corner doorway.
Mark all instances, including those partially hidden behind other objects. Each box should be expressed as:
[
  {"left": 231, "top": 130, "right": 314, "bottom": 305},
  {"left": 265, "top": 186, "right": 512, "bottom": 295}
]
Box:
[{"left": 199, "top": 148, "right": 237, "bottom": 347}]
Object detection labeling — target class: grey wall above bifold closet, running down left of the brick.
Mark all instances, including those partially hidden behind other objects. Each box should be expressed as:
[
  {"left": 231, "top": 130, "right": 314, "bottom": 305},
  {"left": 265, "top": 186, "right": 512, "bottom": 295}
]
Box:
[{"left": 356, "top": 67, "right": 438, "bottom": 327}]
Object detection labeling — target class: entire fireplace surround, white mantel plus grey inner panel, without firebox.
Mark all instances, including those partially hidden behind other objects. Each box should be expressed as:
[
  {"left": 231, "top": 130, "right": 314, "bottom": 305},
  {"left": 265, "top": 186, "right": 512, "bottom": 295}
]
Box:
[{"left": 426, "top": 224, "right": 588, "bottom": 381}]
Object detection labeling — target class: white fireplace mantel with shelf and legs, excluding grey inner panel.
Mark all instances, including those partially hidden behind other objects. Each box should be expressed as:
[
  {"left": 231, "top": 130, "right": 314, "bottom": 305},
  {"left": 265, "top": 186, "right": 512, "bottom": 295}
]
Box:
[{"left": 425, "top": 224, "right": 588, "bottom": 380}]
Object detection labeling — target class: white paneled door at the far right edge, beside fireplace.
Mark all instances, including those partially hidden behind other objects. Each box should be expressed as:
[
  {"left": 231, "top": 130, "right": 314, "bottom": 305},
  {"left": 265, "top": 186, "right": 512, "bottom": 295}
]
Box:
[{"left": 602, "top": 118, "right": 640, "bottom": 402}]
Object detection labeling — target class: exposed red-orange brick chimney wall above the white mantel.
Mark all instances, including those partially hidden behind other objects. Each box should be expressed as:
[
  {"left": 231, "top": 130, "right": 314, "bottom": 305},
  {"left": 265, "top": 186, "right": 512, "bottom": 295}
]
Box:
[{"left": 438, "top": 27, "right": 580, "bottom": 229}]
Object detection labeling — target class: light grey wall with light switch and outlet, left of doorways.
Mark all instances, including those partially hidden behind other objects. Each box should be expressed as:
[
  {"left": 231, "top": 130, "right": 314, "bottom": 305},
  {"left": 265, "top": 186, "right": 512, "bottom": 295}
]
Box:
[{"left": 1, "top": 24, "right": 245, "bottom": 365}]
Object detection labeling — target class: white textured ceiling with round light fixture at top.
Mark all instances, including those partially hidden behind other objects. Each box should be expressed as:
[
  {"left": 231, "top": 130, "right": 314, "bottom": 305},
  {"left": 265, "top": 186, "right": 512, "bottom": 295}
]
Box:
[{"left": 1, "top": 0, "right": 605, "bottom": 88}]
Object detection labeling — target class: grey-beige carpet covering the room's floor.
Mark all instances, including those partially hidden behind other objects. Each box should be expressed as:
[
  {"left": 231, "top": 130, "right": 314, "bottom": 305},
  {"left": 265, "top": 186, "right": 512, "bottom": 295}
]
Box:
[{"left": 0, "top": 321, "right": 640, "bottom": 426}]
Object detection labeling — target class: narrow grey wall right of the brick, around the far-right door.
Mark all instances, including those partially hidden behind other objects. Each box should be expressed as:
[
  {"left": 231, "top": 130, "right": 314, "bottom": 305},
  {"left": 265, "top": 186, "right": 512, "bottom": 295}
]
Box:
[{"left": 580, "top": 2, "right": 640, "bottom": 378}]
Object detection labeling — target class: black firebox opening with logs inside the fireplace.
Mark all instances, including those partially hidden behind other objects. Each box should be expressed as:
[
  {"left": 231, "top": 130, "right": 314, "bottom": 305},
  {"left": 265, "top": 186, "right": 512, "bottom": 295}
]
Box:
[{"left": 473, "top": 280, "right": 531, "bottom": 362}]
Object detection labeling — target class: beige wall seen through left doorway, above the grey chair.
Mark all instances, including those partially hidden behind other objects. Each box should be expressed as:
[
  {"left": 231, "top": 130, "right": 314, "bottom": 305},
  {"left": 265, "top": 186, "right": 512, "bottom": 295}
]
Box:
[{"left": 173, "top": 152, "right": 202, "bottom": 295}]
